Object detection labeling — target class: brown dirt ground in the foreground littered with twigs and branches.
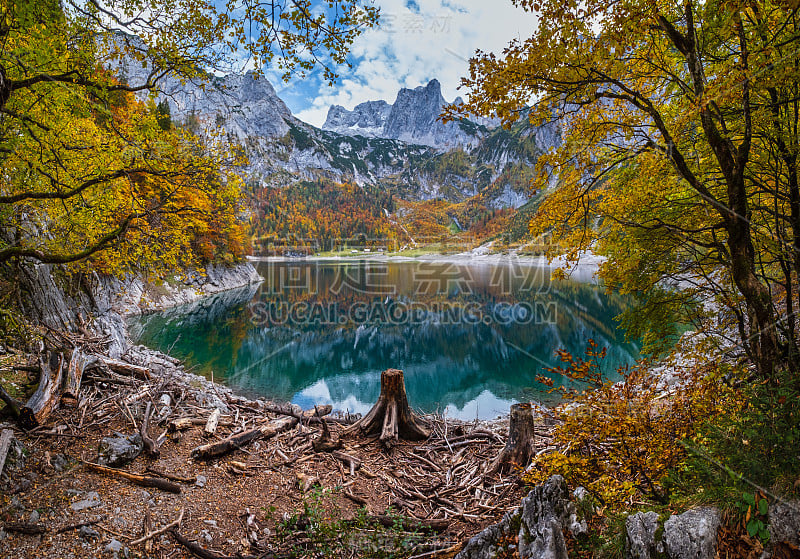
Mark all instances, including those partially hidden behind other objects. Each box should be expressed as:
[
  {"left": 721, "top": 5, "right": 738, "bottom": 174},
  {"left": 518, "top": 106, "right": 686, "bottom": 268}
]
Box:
[{"left": 0, "top": 348, "right": 548, "bottom": 559}]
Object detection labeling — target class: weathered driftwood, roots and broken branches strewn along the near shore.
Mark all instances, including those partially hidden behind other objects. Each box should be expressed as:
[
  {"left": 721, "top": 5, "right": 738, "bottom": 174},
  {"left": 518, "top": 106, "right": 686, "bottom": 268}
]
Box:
[{"left": 0, "top": 330, "right": 551, "bottom": 559}]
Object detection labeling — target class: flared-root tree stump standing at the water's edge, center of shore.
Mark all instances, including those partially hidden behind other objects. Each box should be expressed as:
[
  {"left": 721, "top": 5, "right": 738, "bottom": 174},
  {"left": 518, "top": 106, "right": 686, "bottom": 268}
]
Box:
[{"left": 345, "top": 369, "right": 430, "bottom": 448}]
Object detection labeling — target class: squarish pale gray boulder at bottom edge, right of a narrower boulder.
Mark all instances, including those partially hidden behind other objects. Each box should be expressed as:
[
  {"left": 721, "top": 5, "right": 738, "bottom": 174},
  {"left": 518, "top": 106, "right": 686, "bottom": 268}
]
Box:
[{"left": 664, "top": 507, "right": 721, "bottom": 559}]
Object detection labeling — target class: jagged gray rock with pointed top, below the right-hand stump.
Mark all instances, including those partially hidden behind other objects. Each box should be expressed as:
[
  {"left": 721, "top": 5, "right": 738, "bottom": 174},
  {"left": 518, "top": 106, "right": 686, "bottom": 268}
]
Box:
[{"left": 456, "top": 476, "right": 586, "bottom": 559}]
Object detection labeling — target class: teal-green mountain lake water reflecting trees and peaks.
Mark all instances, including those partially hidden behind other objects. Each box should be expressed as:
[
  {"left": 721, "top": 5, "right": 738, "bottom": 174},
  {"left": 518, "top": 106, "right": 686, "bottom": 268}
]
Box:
[{"left": 129, "top": 260, "right": 639, "bottom": 420}]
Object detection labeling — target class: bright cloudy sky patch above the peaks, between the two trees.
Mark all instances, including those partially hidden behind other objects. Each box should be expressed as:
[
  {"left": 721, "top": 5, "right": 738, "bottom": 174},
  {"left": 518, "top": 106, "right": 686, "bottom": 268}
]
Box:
[{"left": 268, "top": 0, "right": 536, "bottom": 126}]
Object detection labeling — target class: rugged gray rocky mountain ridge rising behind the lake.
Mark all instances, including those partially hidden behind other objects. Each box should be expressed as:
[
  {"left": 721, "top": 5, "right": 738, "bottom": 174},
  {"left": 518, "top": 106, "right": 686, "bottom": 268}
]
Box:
[{"left": 112, "top": 40, "right": 560, "bottom": 208}]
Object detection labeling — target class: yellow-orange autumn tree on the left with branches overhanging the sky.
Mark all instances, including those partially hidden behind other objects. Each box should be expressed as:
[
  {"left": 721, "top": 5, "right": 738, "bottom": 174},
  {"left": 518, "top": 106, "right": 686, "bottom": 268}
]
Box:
[{"left": 0, "top": 0, "right": 377, "bottom": 268}]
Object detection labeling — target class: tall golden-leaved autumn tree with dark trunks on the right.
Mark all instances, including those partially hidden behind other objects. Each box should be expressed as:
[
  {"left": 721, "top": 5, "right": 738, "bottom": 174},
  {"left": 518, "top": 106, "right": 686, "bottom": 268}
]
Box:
[{"left": 452, "top": 0, "right": 800, "bottom": 378}]
